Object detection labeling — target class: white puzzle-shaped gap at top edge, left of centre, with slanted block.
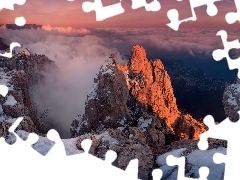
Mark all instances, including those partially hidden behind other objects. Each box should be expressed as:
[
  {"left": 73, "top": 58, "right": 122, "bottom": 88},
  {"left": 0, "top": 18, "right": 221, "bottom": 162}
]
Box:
[{"left": 82, "top": 0, "right": 124, "bottom": 21}]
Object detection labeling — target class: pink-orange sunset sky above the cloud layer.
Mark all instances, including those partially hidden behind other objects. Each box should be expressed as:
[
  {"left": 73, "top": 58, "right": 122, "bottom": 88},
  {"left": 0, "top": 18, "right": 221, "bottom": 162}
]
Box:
[{"left": 0, "top": 0, "right": 239, "bottom": 28}]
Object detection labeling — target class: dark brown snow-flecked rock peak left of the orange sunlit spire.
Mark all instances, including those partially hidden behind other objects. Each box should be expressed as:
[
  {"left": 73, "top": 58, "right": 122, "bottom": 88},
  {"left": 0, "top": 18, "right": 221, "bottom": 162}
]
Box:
[{"left": 71, "top": 64, "right": 133, "bottom": 137}]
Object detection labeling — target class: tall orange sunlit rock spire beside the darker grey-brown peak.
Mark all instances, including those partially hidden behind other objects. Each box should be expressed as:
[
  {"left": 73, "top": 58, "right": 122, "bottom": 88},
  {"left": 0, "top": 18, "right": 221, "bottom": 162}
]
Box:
[{"left": 125, "top": 45, "right": 179, "bottom": 127}]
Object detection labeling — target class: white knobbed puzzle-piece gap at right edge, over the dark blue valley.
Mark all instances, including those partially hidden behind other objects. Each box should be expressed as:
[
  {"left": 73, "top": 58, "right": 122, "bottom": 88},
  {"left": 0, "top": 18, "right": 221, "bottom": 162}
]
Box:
[{"left": 212, "top": 30, "right": 240, "bottom": 78}]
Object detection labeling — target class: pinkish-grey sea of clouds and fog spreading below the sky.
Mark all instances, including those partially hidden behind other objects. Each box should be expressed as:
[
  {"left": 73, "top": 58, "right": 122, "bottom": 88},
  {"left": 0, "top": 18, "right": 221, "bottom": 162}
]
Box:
[{"left": 0, "top": 25, "right": 237, "bottom": 138}]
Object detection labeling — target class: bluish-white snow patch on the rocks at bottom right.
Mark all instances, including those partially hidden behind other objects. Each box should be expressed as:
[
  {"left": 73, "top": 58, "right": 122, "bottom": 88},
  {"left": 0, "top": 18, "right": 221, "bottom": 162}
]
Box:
[{"left": 156, "top": 147, "right": 226, "bottom": 180}]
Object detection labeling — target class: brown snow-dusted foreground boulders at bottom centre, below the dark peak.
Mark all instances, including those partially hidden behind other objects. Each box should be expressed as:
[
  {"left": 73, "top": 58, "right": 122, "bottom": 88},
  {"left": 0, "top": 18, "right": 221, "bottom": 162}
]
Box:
[{"left": 77, "top": 127, "right": 154, "bottom": 179}]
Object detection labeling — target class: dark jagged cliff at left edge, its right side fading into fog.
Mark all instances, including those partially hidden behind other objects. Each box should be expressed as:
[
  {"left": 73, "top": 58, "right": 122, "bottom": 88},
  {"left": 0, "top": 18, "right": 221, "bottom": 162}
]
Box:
[{"left": 0, "top": 52, "right": 58, "bottom": 133}]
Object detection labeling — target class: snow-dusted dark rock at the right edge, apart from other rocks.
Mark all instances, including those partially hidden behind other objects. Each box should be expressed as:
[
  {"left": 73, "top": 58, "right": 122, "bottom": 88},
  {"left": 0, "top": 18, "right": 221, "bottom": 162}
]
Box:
[{"left": 223, "top": 78, "right": 240, "bottom": 122}]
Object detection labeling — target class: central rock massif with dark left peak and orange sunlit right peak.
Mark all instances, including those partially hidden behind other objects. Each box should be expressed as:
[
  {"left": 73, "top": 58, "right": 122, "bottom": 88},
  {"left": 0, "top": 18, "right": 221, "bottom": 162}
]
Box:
[{"left": 71, "top": 45, "right": 206, "bottom": 142}]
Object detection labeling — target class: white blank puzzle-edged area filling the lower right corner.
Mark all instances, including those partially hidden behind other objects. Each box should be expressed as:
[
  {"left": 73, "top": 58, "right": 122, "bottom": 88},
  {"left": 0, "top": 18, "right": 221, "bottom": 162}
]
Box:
[{"left": 198, "top": 111, "right": 240, "bottom": 180}]
